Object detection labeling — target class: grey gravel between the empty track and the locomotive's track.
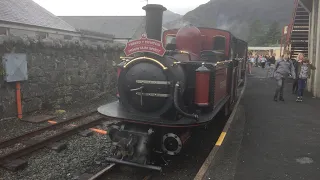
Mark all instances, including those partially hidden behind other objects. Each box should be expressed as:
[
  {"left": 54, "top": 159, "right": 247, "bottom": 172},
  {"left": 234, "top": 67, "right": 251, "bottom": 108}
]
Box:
[{"left": 0, "top": 124, "right": 111, "bottom": 180}]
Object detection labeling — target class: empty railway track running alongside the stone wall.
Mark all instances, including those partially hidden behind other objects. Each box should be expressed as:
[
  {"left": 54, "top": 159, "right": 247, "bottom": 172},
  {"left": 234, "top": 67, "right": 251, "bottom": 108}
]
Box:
[{"left": 0, "top": 112, "right": 104, "bottom": 168}]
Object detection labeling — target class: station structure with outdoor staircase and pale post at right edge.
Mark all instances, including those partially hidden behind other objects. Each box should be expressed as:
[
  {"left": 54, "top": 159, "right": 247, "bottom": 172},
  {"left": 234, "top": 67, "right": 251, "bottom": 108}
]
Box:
[{"left": 281, "top": 0, "right": 320, "bottom": 97}]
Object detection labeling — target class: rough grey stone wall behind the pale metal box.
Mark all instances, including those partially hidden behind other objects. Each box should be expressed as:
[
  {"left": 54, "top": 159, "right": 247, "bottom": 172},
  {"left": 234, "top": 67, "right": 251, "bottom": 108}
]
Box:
[{"left": 0, "top": 35, "right": 123, "bottom": 119}]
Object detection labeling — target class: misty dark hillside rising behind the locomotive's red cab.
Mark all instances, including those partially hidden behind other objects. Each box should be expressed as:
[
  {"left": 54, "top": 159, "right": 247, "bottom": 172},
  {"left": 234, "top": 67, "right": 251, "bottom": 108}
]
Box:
[{"left": 164, "top": 0, "right": 294, "bottom": 40}]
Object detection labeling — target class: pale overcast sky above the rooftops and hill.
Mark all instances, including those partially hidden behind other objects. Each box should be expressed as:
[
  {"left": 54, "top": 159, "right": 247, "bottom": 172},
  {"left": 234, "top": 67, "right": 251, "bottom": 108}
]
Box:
[{"left": 33, "top": 0, "right": 209, "bottom": 16}]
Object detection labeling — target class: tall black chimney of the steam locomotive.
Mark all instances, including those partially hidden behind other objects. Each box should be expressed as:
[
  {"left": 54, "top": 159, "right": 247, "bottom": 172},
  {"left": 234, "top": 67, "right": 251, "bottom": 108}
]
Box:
[{"left": 142, "top": 4, "right": 167, "bottom": 41}]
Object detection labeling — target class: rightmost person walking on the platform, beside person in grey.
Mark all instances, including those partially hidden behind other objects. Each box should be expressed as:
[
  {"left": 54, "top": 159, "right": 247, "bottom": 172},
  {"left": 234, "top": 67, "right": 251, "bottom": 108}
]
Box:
[{"left": 296, "top": 59, "right": 316, "bottom": 102}]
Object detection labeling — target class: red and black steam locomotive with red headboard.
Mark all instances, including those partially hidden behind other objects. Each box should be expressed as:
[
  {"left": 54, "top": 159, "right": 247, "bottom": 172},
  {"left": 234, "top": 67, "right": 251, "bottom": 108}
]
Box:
[{"left": 98, "top": 4, "right": 247, "bottom": 170}]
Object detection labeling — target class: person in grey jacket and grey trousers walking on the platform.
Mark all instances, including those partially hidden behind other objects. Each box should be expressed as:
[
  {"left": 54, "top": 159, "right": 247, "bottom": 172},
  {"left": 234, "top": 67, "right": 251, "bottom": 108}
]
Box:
[{"left": 273, "top": 54, "right": 296, "bottom": 101}]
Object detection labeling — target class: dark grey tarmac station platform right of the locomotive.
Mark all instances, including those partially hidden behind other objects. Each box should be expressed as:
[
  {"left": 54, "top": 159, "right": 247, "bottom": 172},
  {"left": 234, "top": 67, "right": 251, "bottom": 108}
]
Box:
[{"left": 203, "top": 68, "right": 320, "bottom": 180}]
